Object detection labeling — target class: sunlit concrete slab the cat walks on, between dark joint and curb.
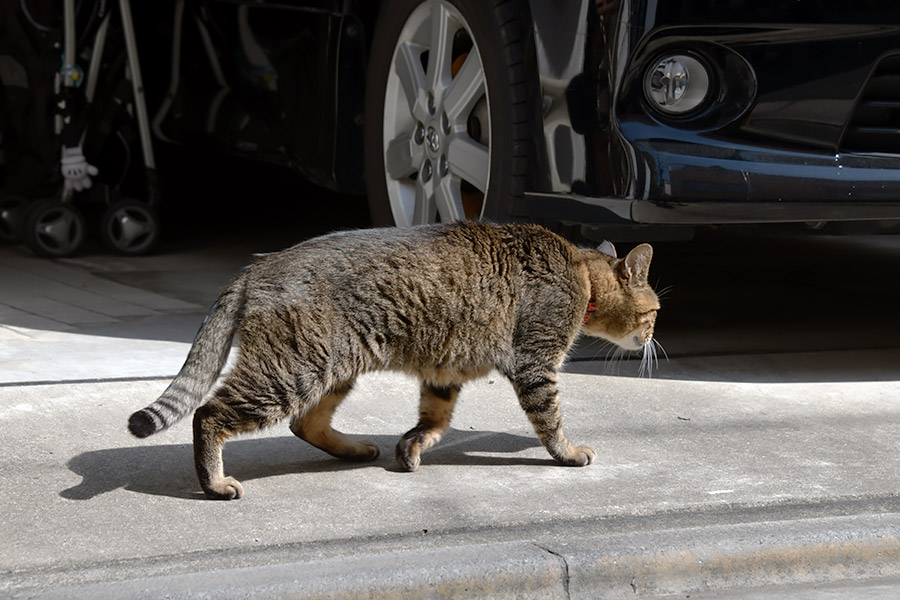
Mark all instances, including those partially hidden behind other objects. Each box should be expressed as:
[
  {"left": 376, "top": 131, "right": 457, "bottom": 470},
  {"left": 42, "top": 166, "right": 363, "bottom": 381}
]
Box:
[{"left": 0, "top": 356, "right": 900, "bottom": 593}]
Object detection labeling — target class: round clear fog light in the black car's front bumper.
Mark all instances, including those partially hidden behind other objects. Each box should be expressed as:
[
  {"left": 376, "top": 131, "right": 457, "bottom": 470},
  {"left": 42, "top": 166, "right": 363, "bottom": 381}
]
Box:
[{"left": 644, "top": 54, "right": 709, "bottom": 115}]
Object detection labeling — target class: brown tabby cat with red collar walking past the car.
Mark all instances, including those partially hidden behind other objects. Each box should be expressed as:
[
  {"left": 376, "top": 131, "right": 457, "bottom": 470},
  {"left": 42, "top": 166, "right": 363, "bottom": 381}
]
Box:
[{"left": 128, "top": 222, "right": 659, "bottom": 499}]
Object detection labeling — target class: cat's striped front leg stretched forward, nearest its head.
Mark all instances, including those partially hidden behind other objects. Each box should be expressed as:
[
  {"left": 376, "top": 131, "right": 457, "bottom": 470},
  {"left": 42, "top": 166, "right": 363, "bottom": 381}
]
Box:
[{"left": 510, "top": 366, "right": 595, "bottom": 467}]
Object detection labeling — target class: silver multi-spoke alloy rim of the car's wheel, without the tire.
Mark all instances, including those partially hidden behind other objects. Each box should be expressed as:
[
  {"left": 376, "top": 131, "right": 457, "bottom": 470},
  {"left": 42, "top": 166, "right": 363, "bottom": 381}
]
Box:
[{"left": 383, "top": 0, "right": 491, "bottom": 226}]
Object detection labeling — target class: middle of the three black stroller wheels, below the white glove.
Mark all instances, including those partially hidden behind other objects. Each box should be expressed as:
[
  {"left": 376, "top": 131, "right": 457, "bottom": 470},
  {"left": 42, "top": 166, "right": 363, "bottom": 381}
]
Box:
[{"left": 22, "top": 200, "right": 85, "bottom": 258}]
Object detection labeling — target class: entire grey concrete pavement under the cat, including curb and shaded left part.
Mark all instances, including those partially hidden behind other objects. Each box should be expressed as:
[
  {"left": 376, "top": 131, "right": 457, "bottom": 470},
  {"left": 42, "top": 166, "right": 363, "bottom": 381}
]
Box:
[{"left": 0, "top": 232, "right": 900, "bottom": 598}]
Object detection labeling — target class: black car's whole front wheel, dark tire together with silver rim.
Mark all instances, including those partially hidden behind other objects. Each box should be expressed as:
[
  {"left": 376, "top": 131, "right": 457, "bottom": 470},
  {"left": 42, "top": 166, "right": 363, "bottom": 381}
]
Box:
[{"left": 364, "top": 0, "right": 534, "bottom": 226}]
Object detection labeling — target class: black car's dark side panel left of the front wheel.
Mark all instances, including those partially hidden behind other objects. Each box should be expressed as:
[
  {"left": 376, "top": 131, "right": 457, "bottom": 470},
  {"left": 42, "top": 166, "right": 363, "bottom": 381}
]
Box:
[{"left": 151, "top": 0, "right": 377, "bottom": 193}]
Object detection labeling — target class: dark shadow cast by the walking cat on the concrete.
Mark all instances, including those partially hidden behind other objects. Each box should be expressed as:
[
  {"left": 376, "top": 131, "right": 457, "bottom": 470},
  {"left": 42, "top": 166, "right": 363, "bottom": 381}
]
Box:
[{"left": 59, "top": 428, "right": 540, "bottom": 500}]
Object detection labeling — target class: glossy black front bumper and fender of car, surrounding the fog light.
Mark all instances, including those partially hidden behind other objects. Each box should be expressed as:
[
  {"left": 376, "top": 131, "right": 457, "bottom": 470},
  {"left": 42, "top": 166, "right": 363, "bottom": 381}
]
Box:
[{"left": 520, "top": 0, "right": 900, "bottom": 223}]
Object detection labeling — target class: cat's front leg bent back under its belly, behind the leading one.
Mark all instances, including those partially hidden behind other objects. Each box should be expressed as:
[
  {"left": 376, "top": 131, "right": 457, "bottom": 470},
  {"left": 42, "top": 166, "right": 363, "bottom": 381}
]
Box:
[{"left": 395, "top": 382, "right": 460, "bottom": 471}]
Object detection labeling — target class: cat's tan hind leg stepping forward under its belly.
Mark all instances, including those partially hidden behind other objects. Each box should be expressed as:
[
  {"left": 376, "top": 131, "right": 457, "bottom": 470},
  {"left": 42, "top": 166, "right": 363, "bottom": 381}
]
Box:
[{"left": 291, "top": 383, "right": 381, "bottom": 461}]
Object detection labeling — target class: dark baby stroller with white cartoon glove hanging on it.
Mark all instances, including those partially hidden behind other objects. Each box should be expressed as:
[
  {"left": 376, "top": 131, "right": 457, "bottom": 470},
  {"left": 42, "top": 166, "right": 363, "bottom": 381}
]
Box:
[{"left": 0, "top": 0, "right": 160, "bottom": 257}]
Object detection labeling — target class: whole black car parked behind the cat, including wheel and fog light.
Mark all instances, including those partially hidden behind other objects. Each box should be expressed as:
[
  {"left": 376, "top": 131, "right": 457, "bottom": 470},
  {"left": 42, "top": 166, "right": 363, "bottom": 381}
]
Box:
[{"left": 107, "top": 0, "right": 900, "bottom": 237}]
